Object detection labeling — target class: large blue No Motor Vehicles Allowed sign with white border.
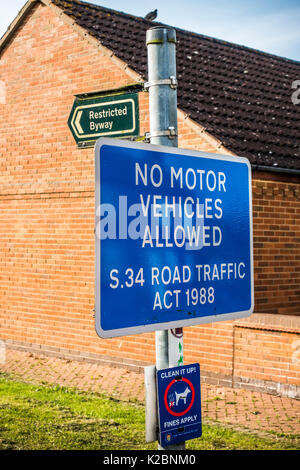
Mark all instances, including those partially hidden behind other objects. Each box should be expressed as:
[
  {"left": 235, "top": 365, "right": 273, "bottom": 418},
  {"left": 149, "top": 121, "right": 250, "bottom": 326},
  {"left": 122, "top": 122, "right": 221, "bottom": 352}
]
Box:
[{"left": 95, "top": 138, "right": 253, "bottom": 338}]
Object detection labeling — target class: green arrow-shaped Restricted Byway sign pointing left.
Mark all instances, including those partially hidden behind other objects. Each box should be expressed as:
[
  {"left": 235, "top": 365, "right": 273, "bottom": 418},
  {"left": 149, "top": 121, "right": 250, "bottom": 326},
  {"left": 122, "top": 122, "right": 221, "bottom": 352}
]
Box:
[{"left": 68, "top": 93, "right": 139, "bottom": 146}]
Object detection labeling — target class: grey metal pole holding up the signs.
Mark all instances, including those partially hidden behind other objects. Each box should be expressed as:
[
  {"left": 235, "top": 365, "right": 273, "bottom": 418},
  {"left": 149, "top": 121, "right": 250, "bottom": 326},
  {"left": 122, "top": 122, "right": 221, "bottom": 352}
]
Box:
[{"left": 145, "top": 26, "right": 185, "bottom": 450}]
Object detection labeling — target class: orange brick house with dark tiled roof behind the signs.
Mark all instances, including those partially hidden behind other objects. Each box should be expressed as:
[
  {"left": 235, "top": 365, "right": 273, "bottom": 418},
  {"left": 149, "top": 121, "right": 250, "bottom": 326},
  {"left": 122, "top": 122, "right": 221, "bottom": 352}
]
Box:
[{"left": 0, "top": 0, "right": 300, "bottom": 397}]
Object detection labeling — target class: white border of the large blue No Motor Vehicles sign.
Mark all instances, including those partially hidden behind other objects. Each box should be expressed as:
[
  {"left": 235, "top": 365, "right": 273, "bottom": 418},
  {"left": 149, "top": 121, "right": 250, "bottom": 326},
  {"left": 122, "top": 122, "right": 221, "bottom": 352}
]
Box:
[{"left": 95, "top": 137, "right": 254, "bottom": 338}]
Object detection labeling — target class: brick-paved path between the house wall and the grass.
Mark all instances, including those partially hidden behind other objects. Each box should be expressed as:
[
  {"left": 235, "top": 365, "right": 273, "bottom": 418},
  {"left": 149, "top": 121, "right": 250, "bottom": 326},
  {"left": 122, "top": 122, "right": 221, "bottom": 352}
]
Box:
[{"left": 0, "top": 349, "right": 300, "bottom": 437}]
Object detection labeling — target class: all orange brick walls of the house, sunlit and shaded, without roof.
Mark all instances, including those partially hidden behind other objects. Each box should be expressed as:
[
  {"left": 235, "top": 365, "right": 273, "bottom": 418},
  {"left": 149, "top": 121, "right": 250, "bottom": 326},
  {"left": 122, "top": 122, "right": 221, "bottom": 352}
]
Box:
[{"left": 0, "top": 5, "right": 300, "bottom": 396}]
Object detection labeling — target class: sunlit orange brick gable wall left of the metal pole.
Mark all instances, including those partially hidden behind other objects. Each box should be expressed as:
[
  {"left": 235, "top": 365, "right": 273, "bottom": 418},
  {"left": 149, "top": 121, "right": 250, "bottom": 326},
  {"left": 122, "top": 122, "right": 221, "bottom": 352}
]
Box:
[{"left": 0, "top": 0, "right": 153, "bottom": 360}]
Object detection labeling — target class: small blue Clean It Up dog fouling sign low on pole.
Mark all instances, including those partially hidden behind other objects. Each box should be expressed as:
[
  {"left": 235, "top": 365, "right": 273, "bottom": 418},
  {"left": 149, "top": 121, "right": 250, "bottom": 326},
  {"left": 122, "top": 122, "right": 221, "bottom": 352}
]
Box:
[{"left": 157, "top": 364, "right": 202, "bottom": 447}]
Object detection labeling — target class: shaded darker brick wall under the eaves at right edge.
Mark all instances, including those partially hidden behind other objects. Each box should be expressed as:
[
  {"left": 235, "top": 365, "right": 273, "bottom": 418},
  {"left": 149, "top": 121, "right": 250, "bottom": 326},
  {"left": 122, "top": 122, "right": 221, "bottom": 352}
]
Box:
[{"left": 253, "top": 176, "right": 300, "bottom": 315}]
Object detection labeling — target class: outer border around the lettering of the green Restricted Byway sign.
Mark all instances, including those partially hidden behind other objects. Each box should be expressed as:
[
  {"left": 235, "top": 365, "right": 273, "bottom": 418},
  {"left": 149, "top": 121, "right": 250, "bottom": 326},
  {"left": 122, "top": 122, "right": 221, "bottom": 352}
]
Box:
[{"left": 68, "top": 90, "right": 140, "bottom": 148}]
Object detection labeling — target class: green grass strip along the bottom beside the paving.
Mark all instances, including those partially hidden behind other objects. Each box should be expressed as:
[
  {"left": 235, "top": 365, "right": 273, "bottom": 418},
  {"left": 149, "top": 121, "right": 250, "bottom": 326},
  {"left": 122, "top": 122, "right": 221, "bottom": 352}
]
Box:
[{"left": 0, "top": 375, "right": 299, "bottom": 450}]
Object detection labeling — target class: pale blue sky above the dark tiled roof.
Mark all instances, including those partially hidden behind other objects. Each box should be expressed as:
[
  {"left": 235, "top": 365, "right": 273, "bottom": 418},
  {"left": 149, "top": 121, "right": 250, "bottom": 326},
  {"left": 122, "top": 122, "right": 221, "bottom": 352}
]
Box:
[{"left": 0, "top": 0, "right": 300, "bottom": 61}]
